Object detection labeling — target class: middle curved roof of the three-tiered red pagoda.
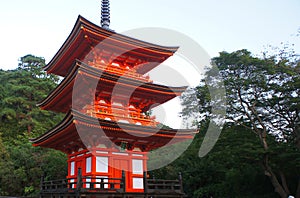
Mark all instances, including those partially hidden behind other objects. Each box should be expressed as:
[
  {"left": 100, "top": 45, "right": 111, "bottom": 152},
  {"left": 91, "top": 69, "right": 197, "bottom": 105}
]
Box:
[{"left": 37, "top": 61, "right": 187, "bottom": 113}]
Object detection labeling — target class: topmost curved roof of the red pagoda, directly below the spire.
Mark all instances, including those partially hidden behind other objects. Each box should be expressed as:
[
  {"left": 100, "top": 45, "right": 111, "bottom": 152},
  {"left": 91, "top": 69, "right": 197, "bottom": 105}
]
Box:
[{"left": 44, "top": 15, "right": 178, "bottom": 76}]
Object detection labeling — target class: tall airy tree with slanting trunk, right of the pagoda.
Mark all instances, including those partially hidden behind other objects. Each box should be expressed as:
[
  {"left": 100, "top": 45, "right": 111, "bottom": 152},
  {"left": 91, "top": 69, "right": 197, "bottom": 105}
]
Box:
[{"left": 183, "top": 50, "right": 300, "bottom": 198}]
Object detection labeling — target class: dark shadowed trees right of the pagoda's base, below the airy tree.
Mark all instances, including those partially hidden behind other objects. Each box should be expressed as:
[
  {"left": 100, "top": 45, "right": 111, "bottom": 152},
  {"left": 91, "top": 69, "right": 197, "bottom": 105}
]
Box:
[{"left": 152, "top": 126, "right": 284, "bottom": 198}]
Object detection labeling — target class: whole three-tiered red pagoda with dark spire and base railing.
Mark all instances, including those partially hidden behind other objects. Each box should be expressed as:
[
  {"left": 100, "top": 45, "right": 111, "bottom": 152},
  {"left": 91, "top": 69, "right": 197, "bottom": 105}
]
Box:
[{"left": 31, "top": 0, "right": 196, "bottom": 197}]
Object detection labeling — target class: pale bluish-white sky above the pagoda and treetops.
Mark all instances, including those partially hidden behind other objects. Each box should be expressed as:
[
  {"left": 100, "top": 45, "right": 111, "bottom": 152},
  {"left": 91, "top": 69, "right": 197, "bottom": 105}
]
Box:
[{"left": 0, "top": 0, "right": 300, "bottom": 70}]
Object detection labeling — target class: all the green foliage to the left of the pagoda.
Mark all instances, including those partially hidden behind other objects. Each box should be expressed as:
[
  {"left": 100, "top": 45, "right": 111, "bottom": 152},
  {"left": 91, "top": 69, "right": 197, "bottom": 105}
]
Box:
[{"left": 0, "top": 55, "right": 67, "bottom": 196}]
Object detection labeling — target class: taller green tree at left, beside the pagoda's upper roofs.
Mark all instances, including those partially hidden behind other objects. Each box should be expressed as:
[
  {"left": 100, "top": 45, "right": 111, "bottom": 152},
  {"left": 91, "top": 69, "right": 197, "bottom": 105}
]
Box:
[{"left": 0, "top": 55, "right": 61, "bottom": 137}]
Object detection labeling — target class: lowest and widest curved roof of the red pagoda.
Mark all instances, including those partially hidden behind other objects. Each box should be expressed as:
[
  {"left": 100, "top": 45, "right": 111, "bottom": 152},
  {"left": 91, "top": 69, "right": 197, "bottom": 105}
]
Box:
[{"left": 30, "top": 110, "right": 197, "bottom": 153}]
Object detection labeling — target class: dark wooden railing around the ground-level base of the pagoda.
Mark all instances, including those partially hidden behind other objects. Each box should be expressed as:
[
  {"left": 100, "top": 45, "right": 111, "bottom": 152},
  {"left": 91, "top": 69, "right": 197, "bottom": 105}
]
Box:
[{"left": 40, "top": 169, "right": 184, "bottom": 198}]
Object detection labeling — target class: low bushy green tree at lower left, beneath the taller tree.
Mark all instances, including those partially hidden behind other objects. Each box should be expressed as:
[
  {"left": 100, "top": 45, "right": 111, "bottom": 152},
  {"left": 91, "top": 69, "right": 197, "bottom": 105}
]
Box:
[{"left": 0, "top": 135, "right": 67, "bottom": 196}]
